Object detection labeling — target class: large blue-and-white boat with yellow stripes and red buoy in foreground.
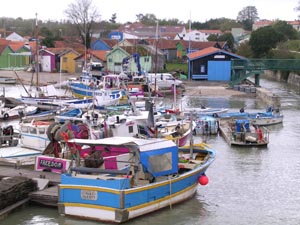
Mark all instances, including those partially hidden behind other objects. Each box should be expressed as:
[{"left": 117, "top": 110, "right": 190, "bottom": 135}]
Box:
[{"left": 58, "top": 137, "right": 215, "bottom": 223}]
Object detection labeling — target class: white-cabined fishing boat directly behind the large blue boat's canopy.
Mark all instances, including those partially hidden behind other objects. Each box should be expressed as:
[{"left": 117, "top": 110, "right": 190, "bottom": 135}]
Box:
[{"left": 104, "top": 102, "right": 196, "bottom": 146}]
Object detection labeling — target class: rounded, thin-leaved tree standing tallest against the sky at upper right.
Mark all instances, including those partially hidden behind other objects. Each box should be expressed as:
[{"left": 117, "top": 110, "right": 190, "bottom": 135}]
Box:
[{"left": 236, "top": 6, "right": 259, "bottom": 30}]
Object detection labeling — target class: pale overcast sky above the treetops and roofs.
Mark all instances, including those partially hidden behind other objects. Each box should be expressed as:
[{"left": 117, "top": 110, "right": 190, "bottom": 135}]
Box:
[{"left": 0, "top": 0, "right": 300, "bottom": 23}]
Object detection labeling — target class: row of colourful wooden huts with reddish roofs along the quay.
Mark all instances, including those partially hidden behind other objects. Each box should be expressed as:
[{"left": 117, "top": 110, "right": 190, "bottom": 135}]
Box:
[{"left": 0, "top": 35, "right": 242, "bottom": 80}]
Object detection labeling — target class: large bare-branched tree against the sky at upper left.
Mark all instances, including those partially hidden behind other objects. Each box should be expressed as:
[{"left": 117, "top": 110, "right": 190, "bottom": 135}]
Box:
[{"left": 65, "top": 0, "right": 100, "bottom": 48}]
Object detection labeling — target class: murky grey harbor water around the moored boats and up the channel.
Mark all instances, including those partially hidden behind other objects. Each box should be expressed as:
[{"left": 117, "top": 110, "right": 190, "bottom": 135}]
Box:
[{"left": 0, "top": 80, "right": 300, "bottom": 225}]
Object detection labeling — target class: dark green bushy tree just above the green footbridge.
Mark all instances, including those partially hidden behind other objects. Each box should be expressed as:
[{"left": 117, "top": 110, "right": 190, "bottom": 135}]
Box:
[{"left": 249, "top": 26, "right": 284, "bottom": 58}]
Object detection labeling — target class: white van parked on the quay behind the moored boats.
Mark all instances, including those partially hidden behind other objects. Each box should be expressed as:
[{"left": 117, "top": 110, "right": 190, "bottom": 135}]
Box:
[{"left": 146, "top": 73, "right": 182, "bottom": 88}]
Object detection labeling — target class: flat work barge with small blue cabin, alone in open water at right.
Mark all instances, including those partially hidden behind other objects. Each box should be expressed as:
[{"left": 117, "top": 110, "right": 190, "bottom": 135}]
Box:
[{"left": 220, "top": 119, "right": 269, "bottom": 147}]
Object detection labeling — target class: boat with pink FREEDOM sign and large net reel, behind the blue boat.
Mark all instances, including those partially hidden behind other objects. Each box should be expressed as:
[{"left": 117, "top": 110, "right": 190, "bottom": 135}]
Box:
[{"left": 34, "top": 117, "right": 104, "bottom": 173}]
